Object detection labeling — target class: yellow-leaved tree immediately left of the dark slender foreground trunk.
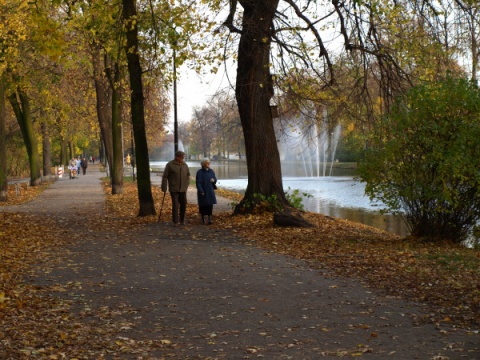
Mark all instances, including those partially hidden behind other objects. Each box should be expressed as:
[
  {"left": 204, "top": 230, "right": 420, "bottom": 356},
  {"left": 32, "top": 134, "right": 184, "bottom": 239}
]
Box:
[{"left": 64, "top": 1, "right": 128, "bottom": 194}]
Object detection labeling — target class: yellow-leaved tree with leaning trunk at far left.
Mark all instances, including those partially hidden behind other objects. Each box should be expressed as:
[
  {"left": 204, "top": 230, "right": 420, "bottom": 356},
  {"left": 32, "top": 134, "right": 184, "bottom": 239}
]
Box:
[{"left": 1, "top": 2, "right": 96, "bottom": 185}]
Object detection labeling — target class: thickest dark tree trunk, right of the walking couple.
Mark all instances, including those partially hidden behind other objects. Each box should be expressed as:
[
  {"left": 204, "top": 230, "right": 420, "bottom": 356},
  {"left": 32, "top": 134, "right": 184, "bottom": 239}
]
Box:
[{"left": 235, "top": 0, "right": 288, "bottom": 212}]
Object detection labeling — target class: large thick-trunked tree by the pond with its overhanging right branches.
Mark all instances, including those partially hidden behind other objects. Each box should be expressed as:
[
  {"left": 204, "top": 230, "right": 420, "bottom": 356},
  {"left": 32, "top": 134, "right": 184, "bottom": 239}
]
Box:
[{"left": 224, "top": 0, "right": 476, "bottom": 219}]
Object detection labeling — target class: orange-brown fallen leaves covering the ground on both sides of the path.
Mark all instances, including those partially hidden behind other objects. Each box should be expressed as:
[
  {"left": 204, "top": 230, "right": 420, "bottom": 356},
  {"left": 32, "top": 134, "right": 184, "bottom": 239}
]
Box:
[{"left": 0, "top": 182, "right": 480, "bottom": 359}]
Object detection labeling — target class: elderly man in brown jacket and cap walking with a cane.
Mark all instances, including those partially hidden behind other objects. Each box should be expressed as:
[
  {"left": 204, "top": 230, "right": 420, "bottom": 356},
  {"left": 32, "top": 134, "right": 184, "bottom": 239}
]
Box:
[{"left": 162, "top": 151, "right": 190, "bottom": 225}]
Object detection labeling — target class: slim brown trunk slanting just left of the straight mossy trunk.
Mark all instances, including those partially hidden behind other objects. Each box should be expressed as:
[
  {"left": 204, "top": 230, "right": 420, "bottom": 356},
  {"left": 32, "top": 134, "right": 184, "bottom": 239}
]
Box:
[{"left": 92, "top": 44, "right": 113, "bottom": 169}]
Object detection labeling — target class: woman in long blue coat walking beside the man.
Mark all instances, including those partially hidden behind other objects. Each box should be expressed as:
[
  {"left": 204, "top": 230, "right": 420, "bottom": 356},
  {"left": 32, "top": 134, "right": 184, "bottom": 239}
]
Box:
[{"left": 196, "top": 159, "right": 217, "bottom": 224}]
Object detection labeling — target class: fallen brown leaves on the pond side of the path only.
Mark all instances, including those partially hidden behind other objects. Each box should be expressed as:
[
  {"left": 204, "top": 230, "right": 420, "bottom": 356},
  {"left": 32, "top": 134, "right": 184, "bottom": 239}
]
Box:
[{"left": 106, "top": 184, "right": 480, "bottom": 328}]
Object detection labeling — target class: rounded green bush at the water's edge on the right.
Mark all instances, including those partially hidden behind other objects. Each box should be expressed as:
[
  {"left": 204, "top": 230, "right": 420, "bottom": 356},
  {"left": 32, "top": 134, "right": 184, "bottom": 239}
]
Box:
[{"left": 358, "top": 78, "right": 480, "bottom": 242}]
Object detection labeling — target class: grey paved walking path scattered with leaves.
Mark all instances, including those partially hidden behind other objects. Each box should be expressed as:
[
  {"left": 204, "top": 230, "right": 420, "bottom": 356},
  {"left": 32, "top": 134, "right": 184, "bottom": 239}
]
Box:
[{"left": 0, "top": 166, "right": 480, "bottom": 360}]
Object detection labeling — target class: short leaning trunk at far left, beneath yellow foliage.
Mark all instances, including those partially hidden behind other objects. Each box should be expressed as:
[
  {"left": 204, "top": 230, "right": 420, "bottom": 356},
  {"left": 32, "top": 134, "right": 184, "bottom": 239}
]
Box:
[{"left": 9, "top": 89, "right": 42, "bottom": 186}]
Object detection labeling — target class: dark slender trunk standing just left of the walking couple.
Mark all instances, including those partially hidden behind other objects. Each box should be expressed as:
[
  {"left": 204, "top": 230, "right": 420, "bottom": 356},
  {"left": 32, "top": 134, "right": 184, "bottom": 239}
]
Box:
[{"left": 122, "top": 0, "right": 155, "bottom": 216}]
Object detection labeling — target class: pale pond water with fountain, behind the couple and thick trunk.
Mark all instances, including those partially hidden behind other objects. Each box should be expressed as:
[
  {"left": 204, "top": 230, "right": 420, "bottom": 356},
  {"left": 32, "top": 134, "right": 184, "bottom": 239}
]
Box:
[{"left": 150, "top": 161, "right": 408, "bottom": 236}]
